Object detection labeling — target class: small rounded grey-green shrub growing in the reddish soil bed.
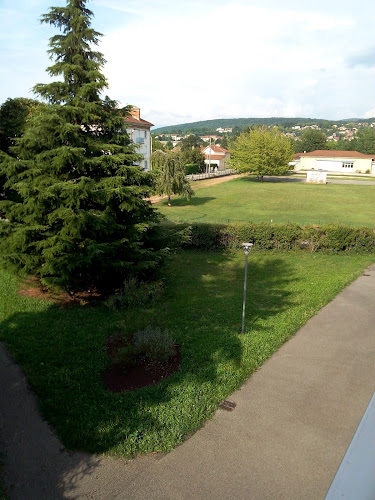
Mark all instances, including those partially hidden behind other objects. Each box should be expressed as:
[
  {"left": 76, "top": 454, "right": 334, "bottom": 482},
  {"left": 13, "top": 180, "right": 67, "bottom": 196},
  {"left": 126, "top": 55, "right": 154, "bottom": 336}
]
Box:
[{"left": 133, "top": 326, "right": 174, "bottom": 361}]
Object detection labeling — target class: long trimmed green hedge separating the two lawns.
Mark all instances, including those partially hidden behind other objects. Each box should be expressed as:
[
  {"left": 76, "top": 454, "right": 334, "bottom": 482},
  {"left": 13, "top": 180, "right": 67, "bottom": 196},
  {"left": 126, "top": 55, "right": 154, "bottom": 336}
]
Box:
[{"left": 163, "top": 222, "right": 375, "bottom": 253}]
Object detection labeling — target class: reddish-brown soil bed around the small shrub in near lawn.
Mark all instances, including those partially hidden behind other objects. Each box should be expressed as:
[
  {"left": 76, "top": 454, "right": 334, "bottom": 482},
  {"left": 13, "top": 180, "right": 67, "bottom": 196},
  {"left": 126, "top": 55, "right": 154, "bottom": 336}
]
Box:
[{"left": 103, "top": 336, "right": 181, "bottom": 392}]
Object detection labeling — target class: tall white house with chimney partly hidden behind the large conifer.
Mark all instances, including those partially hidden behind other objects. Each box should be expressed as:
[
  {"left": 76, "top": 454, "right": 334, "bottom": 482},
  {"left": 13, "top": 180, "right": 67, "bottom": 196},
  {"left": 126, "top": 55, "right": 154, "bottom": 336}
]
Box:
[{"left": 125, "top": 107, "right": 153, "bottom": 170}]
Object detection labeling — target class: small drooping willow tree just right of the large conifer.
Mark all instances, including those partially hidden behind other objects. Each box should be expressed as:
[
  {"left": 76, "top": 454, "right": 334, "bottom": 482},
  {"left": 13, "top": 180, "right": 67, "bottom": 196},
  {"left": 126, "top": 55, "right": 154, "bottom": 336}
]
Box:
[{"left": 150, "top": 151, "right": 194, "bottom": 207}]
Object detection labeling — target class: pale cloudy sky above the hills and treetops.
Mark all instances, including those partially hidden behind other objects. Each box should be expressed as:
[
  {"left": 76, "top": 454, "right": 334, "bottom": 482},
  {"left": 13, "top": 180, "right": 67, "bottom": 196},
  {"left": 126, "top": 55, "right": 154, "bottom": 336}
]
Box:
[{"left": 0, "top": 0, "right": 375, "bottom": 126}]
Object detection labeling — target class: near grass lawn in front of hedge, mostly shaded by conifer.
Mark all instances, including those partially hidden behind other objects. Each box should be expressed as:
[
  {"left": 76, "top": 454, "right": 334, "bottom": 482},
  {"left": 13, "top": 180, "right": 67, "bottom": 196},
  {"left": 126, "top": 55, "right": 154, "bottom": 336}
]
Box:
[{"left": 0, "top": 251, "right": 375, "bottom": 456}]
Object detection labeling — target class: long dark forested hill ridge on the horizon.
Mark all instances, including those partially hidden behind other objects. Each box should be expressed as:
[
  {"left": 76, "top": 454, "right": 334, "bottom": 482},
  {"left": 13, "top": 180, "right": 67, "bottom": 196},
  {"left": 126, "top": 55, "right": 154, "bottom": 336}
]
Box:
[{"left": 152, "top": 117, "right": 374, "bottom": 134}]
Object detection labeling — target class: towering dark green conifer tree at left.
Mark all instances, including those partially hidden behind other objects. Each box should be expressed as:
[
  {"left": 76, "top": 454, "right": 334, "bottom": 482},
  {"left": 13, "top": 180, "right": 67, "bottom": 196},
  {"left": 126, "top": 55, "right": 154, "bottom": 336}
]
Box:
[{"left": 0, "top": 0, "right": 159, "bottom": 290}]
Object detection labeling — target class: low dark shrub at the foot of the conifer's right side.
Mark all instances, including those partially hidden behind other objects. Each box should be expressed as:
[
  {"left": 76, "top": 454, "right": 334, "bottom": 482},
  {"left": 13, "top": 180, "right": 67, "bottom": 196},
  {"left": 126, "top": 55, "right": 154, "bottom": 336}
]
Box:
[{"left": 107, "top": 278, "right": 164, "bottom": 310}]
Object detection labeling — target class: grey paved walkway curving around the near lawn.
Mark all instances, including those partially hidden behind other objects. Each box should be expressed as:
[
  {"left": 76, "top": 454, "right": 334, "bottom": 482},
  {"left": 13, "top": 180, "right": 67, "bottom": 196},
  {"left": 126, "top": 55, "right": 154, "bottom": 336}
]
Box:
[{"left": 0, "top": 265, "right": 375, "bottom": 500}]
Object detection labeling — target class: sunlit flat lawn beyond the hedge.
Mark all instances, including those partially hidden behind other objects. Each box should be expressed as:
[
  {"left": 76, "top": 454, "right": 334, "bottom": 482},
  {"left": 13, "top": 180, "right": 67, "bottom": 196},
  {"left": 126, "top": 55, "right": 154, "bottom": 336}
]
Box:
[{"left": 155, "top": 177, "right": 375, "bottom": 227}]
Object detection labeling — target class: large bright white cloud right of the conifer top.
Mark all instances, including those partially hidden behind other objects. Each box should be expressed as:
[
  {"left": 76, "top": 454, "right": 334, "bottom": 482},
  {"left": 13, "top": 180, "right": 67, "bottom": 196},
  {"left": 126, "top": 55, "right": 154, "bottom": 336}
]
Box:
[{"left": 101, "top": 2, "right": 362, "bottom": 124}]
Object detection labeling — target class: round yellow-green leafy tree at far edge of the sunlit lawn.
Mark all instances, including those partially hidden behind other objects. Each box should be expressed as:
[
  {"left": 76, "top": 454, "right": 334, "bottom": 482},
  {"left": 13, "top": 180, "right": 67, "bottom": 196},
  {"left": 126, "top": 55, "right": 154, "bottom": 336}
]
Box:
[{"left": 230, "top": 127, "right": 293, "bottom": 177}]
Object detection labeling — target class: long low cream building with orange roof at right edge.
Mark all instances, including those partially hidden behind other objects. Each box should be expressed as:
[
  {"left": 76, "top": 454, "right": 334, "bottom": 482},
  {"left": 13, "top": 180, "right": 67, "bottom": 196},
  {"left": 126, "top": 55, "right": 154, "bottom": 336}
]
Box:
[{"left": 292, "top": 150, "right": 375, "bottom": 174}]
